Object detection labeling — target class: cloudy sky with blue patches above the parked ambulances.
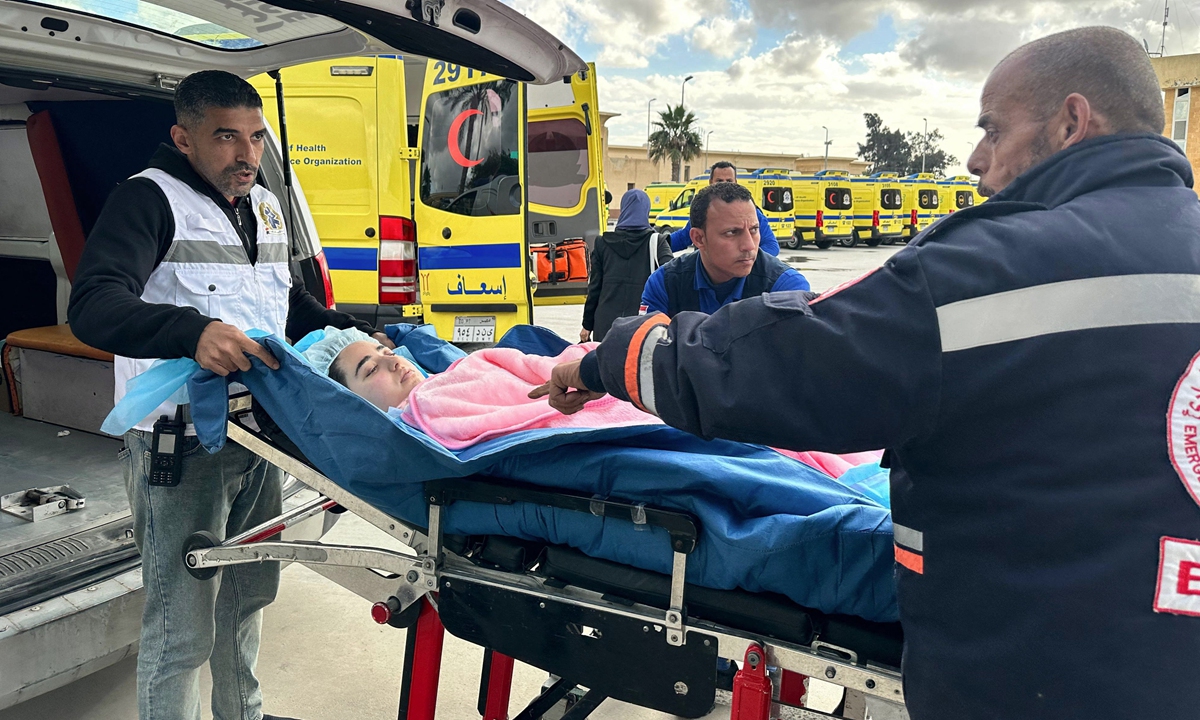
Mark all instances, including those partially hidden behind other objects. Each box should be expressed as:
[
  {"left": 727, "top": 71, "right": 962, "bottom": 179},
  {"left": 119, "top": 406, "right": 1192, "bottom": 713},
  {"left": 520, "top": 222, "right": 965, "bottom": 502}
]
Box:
[{"left": 504, "top": 0, "right": 1176, "bottom": 170}]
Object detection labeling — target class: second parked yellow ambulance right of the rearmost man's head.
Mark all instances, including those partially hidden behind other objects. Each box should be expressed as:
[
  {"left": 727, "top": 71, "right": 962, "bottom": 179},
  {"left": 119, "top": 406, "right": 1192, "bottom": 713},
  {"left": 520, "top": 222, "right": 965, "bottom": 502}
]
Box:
[{"left": 779, "top": 170, "right": 854, "bottom": 250}]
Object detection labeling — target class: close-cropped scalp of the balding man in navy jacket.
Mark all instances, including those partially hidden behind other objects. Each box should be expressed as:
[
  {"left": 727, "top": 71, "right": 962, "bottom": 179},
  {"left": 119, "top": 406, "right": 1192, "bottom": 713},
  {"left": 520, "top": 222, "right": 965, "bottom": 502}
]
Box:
[{"left": 996, "top": 28, "right": 1164, "bottom": 133}]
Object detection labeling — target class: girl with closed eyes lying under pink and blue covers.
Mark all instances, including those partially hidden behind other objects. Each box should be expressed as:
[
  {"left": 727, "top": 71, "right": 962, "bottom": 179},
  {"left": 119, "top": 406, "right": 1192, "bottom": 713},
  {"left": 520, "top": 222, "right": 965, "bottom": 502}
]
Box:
[{"left": 295, "top": 328, "right": 895, "bottom": 620}]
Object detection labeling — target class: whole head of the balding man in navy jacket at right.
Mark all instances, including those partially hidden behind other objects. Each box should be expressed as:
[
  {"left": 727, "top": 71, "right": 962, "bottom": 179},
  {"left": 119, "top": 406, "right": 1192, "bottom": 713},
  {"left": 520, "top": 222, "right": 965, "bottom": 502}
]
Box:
[{"left": 967, "top": 28, "right": 1163, "bottom": 196}]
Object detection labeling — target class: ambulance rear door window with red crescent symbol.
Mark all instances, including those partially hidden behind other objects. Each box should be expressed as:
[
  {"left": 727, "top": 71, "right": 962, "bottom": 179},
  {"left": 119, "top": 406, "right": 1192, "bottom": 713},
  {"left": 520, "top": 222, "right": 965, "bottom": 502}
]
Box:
[{"left": 420, "top": 80, "right": 524, "bottom": 217}]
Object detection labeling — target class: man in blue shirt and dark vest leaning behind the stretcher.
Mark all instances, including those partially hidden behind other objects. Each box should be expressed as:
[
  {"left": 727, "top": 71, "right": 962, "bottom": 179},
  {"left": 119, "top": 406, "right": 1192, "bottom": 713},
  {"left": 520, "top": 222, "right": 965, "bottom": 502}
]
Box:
[{"left": 641, "top": 182, "right": 809, "bottom": 317}]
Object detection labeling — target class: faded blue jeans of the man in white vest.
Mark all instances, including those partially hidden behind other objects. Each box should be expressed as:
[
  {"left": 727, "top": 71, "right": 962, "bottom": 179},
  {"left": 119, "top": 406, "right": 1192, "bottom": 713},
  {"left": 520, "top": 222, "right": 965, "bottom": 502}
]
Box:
[{"left": 121, "top": 430, "right": 283, "bottom": 720}]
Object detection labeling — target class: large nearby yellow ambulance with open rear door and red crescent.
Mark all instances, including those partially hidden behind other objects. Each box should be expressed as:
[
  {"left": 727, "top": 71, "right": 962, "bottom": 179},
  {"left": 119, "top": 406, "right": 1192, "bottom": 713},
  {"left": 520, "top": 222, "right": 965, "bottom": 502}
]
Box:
[{"left": 252, "top": 55, "right": 605, "bottom": 342}]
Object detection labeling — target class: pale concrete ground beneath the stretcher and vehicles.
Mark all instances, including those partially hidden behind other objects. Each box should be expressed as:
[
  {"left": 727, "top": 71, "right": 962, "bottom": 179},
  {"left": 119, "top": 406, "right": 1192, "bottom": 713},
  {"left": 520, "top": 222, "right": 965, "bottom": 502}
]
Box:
[{"left": 0, "top": 247, "right": 898, "bottom": 720}]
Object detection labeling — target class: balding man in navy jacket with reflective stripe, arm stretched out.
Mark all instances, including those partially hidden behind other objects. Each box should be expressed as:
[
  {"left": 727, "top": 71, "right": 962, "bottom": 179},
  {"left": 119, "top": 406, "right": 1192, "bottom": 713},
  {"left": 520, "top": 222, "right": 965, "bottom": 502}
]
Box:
[{"left": 535, "top": 28, "right": 1200, "bottom": 720}]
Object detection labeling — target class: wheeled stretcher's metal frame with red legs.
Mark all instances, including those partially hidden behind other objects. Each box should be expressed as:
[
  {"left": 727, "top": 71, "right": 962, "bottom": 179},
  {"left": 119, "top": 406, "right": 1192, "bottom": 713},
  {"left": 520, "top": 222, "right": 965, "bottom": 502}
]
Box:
[{"left": 182, "top": 395, "right": 907, "bottom": 720}]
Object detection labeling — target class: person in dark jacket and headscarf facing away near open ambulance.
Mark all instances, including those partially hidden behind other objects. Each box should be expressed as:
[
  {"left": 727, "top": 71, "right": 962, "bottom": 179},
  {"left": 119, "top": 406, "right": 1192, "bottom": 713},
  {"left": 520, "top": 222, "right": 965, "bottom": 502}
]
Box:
[{"left": 580, "top": 190, "right": 673, "bottom": 342}]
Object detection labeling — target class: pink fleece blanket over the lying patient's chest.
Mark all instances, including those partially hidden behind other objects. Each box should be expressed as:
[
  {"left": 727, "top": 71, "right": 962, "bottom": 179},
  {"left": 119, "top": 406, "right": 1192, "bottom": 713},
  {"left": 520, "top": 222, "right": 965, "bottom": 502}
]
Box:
[{"left": 401, "top": 342, "right": 662, "bottom": 450}]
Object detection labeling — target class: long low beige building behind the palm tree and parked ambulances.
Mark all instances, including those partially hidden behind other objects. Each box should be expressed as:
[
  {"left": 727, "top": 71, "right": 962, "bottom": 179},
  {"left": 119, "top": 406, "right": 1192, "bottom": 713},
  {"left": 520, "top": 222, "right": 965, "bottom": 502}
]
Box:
[{"left": 604, "top": 143, "right": 868, "bottom": 209}]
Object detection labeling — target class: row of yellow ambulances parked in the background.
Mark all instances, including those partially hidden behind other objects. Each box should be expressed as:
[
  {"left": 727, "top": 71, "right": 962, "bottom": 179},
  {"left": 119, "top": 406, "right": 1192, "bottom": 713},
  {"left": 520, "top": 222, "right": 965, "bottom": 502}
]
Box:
[{"left": 646, "top": 168, "right": 984, "bottom": 250}]
